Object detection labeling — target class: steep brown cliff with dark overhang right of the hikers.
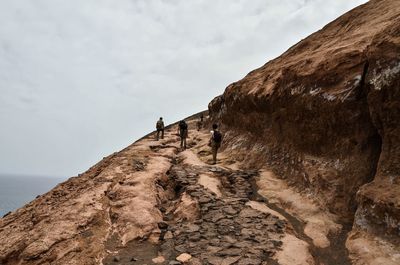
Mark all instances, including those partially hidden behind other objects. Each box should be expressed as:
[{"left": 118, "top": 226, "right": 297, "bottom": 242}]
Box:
[{"left": 209, "top": 0, "right": 400, "bottom": 252}]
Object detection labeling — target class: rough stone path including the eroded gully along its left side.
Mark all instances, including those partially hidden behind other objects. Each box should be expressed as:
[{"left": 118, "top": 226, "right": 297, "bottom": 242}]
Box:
[{"left": 104, "top": 132, "right": 286, "bottom": 265}]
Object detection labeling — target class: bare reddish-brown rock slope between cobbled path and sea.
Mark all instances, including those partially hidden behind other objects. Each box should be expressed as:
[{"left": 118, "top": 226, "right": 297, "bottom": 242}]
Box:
[{"left": 0, "top": 137, "right": 175, "bottom": 265}]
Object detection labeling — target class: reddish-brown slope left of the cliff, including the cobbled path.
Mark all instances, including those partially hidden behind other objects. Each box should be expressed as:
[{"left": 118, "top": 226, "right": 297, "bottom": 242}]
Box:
[{"left": 0, "top": 117, "right": 315, "bottom": 265}]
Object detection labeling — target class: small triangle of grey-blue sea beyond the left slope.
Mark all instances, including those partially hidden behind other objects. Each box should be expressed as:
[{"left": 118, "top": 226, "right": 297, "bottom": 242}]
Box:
[{"left": 0, "top": 175, "right": 66, "bottom": 218}]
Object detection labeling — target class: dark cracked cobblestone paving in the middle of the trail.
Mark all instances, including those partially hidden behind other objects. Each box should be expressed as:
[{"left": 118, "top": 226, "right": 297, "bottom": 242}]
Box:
[{"left": 155, "top": 165, "right": 285, "bottom": 265}]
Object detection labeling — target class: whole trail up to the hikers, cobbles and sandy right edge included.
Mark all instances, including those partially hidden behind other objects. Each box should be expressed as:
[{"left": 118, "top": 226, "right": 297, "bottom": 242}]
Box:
[{"left": 103, "top": 118, "right": 356, "bottom": 265}]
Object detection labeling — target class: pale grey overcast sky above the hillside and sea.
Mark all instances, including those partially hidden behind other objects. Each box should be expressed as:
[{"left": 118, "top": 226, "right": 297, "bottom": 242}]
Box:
[{"left": 0, "top": 0, "right": 366, "bottom": 177}]
